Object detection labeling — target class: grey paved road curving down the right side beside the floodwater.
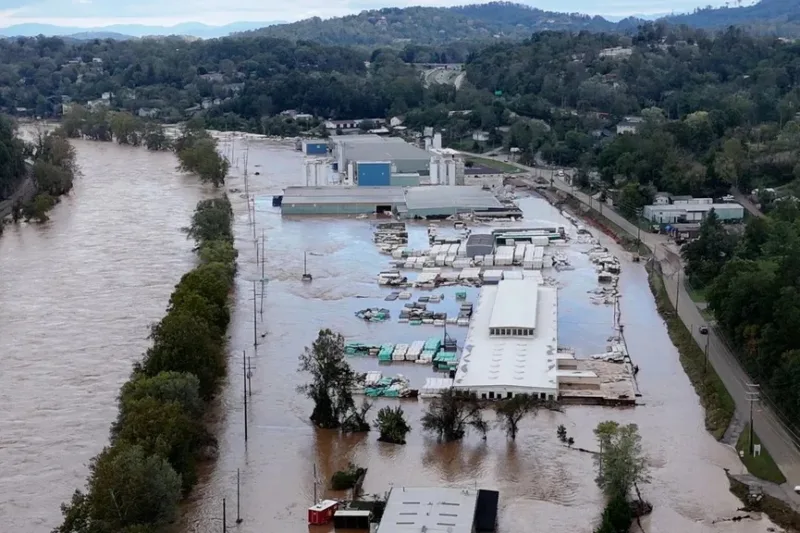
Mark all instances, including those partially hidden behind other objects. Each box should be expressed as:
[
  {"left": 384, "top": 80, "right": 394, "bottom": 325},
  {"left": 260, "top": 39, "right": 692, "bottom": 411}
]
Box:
[{"left": 467, "top": 150, "right": 800, "bottom": 502}]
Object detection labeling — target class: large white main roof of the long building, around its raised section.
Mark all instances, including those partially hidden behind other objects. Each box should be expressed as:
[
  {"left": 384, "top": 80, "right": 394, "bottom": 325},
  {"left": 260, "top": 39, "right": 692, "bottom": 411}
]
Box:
[{"left": 453, "top": 280, "right": 558, "bottom": 393}]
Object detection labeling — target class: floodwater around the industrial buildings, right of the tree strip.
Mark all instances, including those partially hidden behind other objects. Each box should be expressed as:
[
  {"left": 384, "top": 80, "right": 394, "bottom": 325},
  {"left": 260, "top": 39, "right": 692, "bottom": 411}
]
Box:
[{"left": 185, "top": 139, "right": 771, "bottom": 533}]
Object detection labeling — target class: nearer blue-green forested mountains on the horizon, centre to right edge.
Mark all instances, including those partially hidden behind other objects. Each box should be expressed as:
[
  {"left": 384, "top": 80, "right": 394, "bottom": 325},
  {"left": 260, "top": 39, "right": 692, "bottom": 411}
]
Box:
[{"left": 245, "top": 0, "right": 800, "bottom": 46}]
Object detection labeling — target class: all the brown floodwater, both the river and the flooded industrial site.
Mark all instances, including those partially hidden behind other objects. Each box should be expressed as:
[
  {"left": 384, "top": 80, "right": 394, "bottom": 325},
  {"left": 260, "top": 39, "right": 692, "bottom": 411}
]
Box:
[{"left": 0, "top": 133, "right": 771, "bottom": 533}]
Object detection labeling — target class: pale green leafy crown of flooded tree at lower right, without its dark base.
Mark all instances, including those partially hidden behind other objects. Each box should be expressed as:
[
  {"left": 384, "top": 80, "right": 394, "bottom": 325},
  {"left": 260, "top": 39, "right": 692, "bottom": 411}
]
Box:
[{"left": 594, "top": 421, "right": 650, "bottom": 499}]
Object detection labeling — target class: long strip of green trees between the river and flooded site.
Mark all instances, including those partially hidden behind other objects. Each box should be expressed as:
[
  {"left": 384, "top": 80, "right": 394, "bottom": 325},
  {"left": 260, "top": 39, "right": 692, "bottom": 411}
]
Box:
[{"left": 54, "top": 197, "right": 236, "bottom": 533}]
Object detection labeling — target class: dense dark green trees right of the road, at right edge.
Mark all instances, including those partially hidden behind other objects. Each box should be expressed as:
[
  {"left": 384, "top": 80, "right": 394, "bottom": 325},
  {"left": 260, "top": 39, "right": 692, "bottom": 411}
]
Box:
[{"left": 683, "top": 205, "right": 800, "bottom": 436}]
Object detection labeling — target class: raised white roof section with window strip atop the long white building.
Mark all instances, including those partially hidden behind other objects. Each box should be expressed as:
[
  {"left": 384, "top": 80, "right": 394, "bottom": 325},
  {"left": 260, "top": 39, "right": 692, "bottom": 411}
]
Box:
[{"left": 489, "top": 276, "right": 539, "bottom": 328}]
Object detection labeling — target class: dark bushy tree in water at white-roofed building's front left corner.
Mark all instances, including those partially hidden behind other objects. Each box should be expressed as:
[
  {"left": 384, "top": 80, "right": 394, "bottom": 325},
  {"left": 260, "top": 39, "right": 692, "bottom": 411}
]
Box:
[{"left": 422, "top": 389, "right": 487, "bottom": 442}]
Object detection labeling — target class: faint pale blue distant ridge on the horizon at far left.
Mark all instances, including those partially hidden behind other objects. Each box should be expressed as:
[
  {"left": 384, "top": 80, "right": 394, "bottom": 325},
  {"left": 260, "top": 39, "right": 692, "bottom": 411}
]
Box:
[{"left": 0, "top": 21, "right": 282, "bottom": 40}]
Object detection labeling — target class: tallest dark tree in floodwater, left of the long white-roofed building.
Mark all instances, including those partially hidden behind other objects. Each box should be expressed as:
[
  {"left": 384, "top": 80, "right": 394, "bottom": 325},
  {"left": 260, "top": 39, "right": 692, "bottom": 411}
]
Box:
[{"left": 298, "top": 329, "right": 356, "bottom": 428}]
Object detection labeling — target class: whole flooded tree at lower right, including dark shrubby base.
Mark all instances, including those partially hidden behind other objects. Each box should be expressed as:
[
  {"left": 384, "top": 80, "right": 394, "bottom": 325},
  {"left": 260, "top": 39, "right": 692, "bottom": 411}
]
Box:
[{"left": 594, "top": 421, "right": 652, "bottom": 533}]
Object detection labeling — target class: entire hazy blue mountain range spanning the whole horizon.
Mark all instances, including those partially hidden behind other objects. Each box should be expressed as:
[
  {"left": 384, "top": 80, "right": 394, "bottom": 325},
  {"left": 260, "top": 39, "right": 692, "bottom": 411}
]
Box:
[{"left": 0, "top": 0, "right": 800, "bottom": 46}]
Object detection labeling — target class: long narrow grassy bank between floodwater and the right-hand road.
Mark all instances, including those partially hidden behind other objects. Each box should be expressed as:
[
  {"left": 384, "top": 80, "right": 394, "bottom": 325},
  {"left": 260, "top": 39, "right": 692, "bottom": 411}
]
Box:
[{"left": 648, "top": 268, "right": 736, "bottom": 440}]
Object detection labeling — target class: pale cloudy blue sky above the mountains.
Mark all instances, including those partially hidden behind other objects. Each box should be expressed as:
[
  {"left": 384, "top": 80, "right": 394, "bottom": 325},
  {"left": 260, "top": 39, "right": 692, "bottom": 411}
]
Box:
[{"left": 0, "top": 0, "right": 724, "bottom": 27}]
